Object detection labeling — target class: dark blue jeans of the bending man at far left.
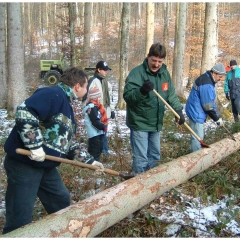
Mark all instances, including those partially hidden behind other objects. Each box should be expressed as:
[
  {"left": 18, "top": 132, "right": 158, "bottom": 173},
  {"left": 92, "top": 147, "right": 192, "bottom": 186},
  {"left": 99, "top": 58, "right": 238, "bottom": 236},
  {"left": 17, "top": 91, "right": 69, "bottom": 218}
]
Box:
[{"left": 3, "top": 155, "right": 70, "bottom": 234}]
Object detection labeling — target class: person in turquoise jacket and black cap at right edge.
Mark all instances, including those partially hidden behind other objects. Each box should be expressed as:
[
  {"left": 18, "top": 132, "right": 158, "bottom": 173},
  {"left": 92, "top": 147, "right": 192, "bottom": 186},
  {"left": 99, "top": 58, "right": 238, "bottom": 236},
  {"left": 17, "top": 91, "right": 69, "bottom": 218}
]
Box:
[{"left": 224, "top": 60, "right": 240, "bottom": 122}]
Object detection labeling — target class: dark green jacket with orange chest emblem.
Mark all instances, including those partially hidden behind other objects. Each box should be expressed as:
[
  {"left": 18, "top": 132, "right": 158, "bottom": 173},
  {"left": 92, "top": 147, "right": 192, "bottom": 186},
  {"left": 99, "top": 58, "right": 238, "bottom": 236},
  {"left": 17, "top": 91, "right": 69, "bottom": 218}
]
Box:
[{"left": 123, "top": 58, "right": 183, "bottom": 132}]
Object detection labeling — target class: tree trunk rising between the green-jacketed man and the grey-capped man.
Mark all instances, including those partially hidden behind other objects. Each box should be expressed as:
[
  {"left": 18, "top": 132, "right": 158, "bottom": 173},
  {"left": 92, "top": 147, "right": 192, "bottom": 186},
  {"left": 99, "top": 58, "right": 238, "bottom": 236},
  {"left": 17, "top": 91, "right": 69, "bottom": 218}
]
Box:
[{"left": 173, "top": 2, "right": 187, "bottom": 98}]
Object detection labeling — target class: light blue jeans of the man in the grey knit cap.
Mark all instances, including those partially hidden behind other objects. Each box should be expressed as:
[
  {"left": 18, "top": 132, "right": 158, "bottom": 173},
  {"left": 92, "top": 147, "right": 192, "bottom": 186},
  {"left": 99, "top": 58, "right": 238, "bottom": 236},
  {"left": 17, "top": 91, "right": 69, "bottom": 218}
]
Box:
[{"left": 189, "top": 119, "right": 204, "bottom": 152}]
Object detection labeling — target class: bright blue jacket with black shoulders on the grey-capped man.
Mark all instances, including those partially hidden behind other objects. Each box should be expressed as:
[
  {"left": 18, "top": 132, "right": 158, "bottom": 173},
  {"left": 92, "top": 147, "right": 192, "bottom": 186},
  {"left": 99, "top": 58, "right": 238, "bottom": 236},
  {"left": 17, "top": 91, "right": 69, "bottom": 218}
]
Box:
[{"left": 186, "top": 71, "right": 219, "bottom": 123}]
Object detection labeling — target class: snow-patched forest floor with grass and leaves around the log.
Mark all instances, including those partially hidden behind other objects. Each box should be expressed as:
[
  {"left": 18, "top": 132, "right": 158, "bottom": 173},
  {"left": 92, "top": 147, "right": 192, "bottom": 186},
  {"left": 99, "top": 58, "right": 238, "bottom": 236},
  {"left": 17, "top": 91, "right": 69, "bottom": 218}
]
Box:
[{"left": 0, "top": 80, "right": 240, "bottom": 238}]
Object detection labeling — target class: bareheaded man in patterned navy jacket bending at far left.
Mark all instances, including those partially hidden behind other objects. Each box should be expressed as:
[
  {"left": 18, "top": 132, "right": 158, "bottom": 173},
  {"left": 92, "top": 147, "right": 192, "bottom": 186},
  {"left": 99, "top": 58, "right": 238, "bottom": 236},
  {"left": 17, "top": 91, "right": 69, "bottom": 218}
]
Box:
[{"left": 3, "top": 67, "right": 103, "bottom": 234}]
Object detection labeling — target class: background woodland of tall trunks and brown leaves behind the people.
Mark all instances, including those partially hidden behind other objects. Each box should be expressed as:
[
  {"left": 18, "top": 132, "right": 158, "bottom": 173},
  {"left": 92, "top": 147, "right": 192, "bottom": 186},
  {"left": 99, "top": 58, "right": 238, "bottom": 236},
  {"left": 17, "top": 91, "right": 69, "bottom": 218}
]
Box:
[{"left": 0, "top": 2, "right": 240, "bottom": 115}]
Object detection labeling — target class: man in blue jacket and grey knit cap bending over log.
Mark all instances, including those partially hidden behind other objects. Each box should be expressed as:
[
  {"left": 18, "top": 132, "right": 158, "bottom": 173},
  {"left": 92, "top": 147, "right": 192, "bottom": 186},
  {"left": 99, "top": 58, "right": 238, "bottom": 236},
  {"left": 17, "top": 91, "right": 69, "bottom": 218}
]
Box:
[{"left": 186, "top": 63, "right": 226, "bottom": 152}]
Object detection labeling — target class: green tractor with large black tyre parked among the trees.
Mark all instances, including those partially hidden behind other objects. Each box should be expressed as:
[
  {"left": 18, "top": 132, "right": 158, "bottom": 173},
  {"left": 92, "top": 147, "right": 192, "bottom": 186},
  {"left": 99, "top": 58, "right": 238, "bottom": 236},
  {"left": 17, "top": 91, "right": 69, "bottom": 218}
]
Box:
[{"left": 39, "top": 57, "right": 95, "bottom": 86}]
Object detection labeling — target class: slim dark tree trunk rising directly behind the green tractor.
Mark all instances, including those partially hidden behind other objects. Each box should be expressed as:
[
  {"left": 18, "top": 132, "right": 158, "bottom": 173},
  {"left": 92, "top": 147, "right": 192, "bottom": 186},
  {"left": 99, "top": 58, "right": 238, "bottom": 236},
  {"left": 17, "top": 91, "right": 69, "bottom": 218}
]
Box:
[{"left": 68, "top": 2, "right": 76, "bottom": 67}]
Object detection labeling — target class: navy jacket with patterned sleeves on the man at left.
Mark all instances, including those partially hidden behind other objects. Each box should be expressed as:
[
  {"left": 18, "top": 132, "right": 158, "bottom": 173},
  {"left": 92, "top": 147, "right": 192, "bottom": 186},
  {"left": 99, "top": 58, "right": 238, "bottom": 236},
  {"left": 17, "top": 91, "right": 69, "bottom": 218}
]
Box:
[{"left": 4, "top": 83, "right": 79, "bottom": 168}]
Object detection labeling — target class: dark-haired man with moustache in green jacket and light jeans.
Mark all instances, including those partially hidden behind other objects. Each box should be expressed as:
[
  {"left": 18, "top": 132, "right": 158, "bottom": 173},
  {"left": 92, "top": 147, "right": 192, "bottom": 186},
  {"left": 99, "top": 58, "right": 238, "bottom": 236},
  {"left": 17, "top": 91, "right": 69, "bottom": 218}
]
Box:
[{"left": 123, "top": 43, "right": 185, "bottom": 174}]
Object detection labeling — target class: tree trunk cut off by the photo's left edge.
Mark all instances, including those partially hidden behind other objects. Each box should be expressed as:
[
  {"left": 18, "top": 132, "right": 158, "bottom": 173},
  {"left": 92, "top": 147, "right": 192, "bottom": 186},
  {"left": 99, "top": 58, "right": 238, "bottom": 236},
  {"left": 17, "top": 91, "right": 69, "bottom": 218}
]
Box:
[{"left": 0, "top": 3, "right": 7, "bottom": 108}]
